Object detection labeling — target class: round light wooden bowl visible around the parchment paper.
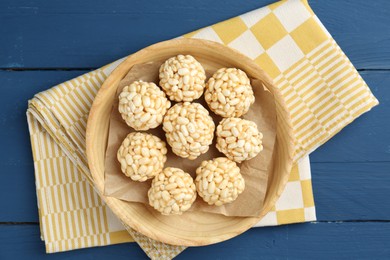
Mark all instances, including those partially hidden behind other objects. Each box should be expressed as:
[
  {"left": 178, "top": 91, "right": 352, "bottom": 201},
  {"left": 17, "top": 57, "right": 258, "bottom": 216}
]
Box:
[{"left": 86, "top": 39, "right": 293, "bottom": 246}]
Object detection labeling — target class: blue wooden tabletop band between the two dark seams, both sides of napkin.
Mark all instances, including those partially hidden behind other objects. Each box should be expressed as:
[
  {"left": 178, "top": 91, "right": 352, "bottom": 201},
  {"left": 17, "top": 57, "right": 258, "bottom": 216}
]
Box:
[{"left": 0, "top": 71, "right": 390, "bottom": 222}]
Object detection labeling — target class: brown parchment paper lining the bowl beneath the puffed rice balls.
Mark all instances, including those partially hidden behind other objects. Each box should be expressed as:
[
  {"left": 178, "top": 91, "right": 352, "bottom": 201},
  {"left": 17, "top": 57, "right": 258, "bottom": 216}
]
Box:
[{"left": 104, "top": 61, "right": 276, "bottom": 217}]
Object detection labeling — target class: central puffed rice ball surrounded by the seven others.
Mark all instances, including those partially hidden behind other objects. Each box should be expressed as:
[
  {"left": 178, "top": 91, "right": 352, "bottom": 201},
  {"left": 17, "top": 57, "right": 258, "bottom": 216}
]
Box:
[{"left": 163, "top": 102, "right": 215, "bottom": 160}]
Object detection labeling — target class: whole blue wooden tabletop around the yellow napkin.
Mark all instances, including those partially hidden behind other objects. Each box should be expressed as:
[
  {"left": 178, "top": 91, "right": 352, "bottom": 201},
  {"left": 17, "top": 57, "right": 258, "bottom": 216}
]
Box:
[{"left": 0, "top": 0, "right": 390, "bottom": 259}]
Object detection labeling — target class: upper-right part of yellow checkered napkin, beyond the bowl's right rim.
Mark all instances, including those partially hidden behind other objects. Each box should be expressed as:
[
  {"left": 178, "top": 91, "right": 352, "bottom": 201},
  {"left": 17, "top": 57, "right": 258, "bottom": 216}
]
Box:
[{"left": 184, "top": 0, "right": 378, "bottom": 160}]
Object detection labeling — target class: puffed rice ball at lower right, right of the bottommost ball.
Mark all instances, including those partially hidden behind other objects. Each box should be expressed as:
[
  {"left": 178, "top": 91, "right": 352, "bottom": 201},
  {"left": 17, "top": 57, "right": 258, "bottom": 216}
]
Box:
[{"left": 195, "top": 157, "right": 245, "bottom": 206}]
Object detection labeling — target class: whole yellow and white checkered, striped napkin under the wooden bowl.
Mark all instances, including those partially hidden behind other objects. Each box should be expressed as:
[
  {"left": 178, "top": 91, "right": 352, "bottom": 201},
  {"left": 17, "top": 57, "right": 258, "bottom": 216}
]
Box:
[{"left": 27, "top": 0, "right": 378, "bottom": 259}]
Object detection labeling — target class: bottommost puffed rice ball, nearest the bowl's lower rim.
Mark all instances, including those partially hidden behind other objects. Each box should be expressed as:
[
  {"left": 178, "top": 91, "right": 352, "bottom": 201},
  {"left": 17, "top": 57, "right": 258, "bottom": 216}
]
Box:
[{"left": 148, "top": 167, "right": 196, "bottom": 215}]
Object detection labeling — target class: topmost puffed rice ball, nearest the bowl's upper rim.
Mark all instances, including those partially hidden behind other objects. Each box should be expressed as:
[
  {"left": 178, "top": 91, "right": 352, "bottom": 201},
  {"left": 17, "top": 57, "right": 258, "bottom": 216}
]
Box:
[{"left": 159, "top": 55, "right": 206, "bottom": 102}]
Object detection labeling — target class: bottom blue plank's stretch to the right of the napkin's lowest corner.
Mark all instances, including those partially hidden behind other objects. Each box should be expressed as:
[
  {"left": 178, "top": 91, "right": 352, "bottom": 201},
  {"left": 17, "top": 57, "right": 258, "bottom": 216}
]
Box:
[{"left": 182, "top": 223, "right": 390, "bottom": 259}]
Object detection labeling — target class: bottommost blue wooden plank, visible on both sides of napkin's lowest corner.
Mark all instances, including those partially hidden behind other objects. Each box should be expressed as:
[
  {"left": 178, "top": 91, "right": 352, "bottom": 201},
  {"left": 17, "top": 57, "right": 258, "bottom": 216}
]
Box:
[{"left": 0, "top": 223, "right": 390, "bottom": 259}]
